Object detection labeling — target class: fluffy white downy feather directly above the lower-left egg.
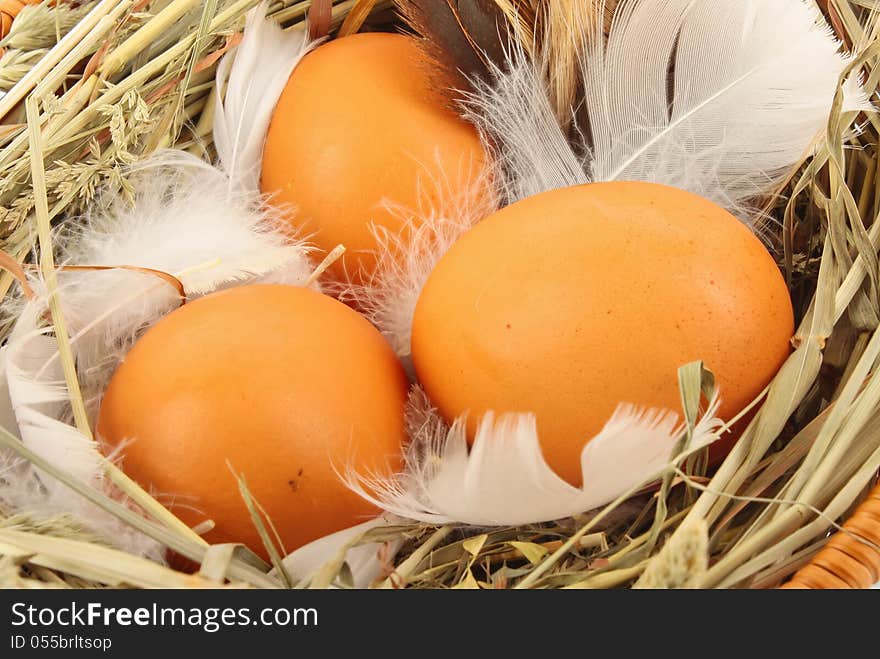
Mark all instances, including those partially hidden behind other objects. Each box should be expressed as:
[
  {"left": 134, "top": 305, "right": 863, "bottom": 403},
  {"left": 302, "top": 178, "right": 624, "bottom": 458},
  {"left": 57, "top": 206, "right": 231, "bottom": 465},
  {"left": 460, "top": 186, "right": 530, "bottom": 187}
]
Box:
[{"left": 61, "top": 150, "right": 311, "bottom": 295}]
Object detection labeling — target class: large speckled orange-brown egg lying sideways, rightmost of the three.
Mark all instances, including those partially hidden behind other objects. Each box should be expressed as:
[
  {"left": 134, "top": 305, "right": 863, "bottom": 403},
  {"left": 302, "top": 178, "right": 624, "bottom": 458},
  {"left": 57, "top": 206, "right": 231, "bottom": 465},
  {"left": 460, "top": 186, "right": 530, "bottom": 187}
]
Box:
[{"left": 412, "top": 182, "right": 794, "bottom": 484}]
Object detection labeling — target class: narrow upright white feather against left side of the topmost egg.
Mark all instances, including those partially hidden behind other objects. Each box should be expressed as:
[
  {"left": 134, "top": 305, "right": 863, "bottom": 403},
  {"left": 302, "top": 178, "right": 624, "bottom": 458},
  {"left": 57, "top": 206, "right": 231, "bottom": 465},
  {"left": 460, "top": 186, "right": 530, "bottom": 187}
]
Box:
[{"left": 214, "top": 2, "right": 319, "bottom": 191}]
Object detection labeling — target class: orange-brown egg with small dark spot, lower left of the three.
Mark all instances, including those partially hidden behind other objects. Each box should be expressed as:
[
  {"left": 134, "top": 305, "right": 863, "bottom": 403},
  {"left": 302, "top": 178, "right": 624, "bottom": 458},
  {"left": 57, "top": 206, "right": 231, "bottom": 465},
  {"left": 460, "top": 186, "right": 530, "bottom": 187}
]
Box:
[{"left": 98, "top": 285, "right": 408, "bottom": 556}]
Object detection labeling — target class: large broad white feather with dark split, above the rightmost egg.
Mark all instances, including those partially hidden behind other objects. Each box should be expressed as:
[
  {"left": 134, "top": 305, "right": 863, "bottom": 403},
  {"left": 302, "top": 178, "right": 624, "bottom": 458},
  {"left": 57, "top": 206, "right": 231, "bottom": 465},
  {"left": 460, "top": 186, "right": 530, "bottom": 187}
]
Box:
[{"left": 584, "top": 0, "right": 870, "bottom": 208}]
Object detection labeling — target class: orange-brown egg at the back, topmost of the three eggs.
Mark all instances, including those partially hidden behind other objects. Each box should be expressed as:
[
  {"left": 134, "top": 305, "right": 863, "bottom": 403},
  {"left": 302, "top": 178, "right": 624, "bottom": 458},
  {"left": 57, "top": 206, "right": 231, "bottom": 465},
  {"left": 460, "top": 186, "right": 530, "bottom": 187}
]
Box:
[{"left": 261, "top": 33, "right": 484, "bottom": 280}]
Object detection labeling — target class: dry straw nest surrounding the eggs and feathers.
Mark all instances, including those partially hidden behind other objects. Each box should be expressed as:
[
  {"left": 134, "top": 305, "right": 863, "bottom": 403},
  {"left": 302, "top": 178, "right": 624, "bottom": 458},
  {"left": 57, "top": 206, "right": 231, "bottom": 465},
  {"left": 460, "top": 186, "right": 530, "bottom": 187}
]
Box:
[{"left": 0, "top": 0, "right": 880, "bottom": 588}]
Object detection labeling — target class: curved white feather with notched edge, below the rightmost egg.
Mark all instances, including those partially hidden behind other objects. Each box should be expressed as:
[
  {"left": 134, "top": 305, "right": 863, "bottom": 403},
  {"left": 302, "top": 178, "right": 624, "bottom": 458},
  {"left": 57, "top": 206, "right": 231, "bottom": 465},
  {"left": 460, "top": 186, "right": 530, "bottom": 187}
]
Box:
[{"left": 347, "top": 390, "right": 721, "bottom": 526}]
